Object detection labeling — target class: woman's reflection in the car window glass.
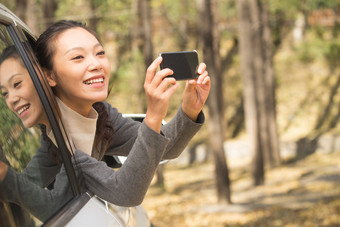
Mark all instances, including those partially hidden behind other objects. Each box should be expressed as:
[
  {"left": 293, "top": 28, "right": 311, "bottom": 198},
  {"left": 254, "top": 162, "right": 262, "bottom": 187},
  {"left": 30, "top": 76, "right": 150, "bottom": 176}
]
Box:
[{"left": 0, "top": 46, "right": 72, "bottom": 223}]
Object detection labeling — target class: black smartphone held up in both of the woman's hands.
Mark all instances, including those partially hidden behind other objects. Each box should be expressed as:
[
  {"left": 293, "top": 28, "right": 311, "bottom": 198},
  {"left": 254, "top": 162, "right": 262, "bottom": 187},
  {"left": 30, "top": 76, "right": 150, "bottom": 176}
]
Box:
[{"left": 159, "top": 50, "right": 198, "bottom": 80}]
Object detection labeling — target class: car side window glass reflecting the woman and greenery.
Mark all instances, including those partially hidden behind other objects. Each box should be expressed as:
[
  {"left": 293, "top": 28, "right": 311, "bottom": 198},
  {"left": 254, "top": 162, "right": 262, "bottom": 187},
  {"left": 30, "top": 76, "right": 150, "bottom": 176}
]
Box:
[{"left": 0, "top": 21, "right": 74, "bottom": 226}]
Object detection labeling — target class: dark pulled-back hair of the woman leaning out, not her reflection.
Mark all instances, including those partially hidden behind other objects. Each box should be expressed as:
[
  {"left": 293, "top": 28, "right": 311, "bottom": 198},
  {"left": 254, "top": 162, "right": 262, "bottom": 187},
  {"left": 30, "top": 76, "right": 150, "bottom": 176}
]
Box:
[{"left": 35, "top": 20, "right": 113, "bottom": 154}]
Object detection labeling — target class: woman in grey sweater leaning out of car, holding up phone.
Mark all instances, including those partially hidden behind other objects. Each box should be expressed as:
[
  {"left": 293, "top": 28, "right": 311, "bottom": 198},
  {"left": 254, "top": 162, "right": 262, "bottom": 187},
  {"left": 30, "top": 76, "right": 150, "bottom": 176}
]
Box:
[{"left": 0, "top": 21, "right": 210, "bottom": 221}]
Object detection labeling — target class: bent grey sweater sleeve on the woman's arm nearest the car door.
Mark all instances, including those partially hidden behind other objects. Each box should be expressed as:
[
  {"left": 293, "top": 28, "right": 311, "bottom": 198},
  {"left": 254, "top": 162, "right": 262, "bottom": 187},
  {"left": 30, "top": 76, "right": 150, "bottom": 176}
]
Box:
[{"left": 75, "top": 123, "right": 169, "bottom": 207}]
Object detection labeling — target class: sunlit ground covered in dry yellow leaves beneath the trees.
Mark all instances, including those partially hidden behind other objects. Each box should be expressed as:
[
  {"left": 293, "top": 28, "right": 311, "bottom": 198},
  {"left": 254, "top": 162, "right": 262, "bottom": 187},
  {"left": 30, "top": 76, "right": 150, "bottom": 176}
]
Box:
[{"left": 143, "top": 152, "right": 340, "bottom": 227}]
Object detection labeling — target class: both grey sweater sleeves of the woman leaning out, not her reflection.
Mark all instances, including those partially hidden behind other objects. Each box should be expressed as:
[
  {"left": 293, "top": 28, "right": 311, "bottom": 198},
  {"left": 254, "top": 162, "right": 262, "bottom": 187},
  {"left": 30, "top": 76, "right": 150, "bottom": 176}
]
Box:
[{"left": 75, "top": 104, "right": 204, "bottom": 206}]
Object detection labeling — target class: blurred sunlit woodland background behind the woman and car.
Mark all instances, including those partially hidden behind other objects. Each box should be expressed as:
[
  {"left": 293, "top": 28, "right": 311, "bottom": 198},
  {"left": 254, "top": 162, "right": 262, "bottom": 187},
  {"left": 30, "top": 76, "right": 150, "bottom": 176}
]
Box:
[{"left": 2, "top": 0, "right": 340, "bottom": 226}]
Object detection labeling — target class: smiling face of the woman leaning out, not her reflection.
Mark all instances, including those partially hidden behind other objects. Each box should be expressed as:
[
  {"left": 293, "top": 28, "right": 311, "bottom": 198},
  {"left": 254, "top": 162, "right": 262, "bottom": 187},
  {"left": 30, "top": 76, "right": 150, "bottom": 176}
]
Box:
[{"left": 49, "top": 27, "right": 110, "bottom": 116}]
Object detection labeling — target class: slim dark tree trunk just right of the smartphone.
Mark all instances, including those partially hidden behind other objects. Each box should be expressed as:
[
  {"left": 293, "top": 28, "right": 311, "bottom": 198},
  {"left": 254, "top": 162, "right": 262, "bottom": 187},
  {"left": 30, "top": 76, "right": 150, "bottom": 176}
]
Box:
[{"left": 199, "top": 0, "right": 231, "bottom": 203}]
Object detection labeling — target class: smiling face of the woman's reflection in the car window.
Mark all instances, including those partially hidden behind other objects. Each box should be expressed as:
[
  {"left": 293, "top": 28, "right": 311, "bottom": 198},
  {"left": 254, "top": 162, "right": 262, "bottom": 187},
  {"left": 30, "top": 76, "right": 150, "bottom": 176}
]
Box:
[{"left": 0, "top": 57, "right": 48, "bottom": 128}]
